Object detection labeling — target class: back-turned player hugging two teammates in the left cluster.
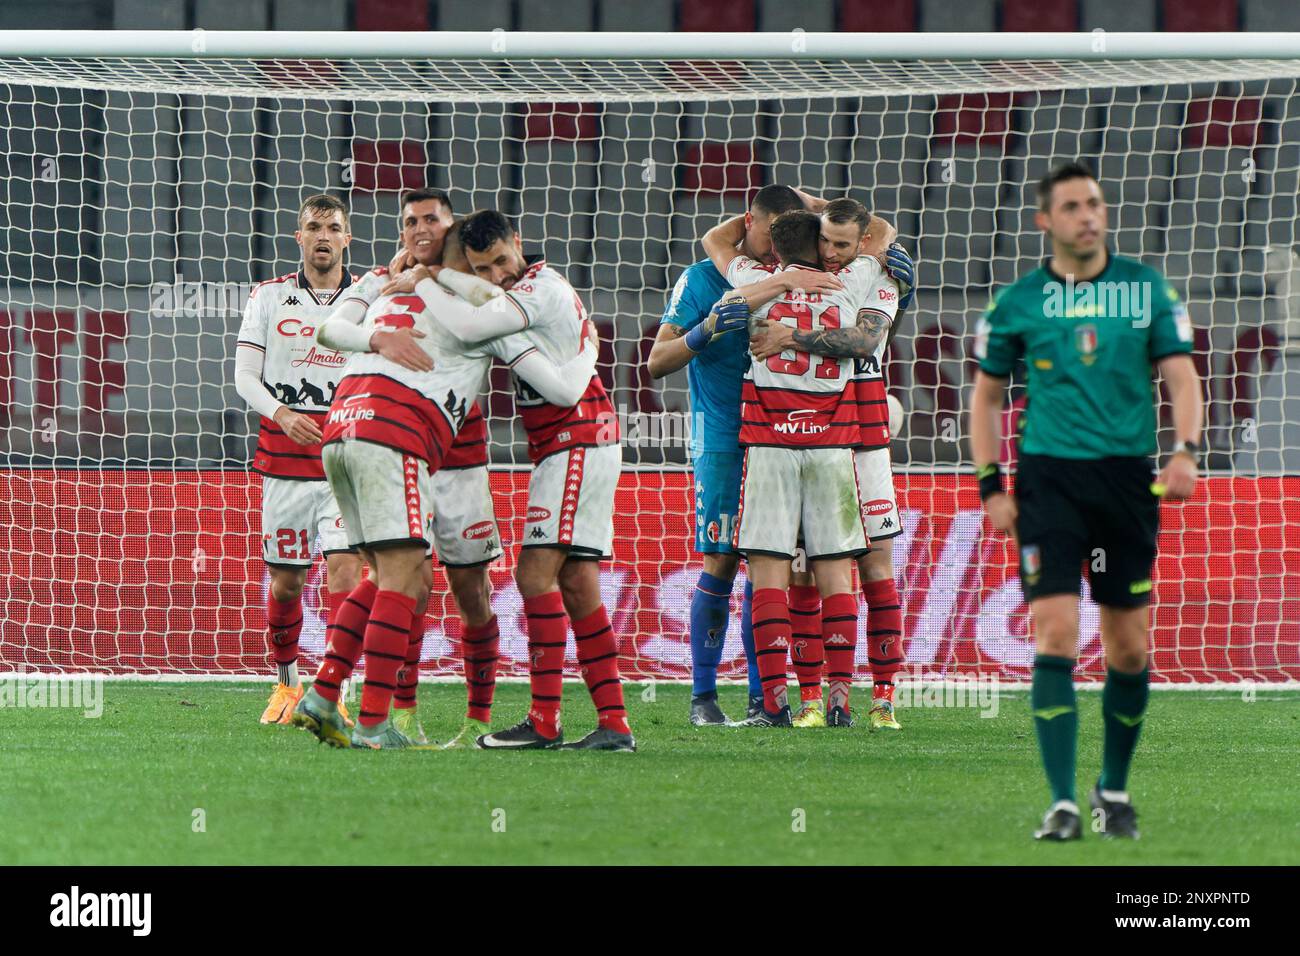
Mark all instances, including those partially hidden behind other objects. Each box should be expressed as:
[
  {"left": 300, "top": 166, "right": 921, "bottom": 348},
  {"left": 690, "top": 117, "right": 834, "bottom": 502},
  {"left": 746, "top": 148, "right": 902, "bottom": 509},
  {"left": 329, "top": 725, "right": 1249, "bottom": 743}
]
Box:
[{"left": 293, "top": 239, "right": 595, "bottom": 749}]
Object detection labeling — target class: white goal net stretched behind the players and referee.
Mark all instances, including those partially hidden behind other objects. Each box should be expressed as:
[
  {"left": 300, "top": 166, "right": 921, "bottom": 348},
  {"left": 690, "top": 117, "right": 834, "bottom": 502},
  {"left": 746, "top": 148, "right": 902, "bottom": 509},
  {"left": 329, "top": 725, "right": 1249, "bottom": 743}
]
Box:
[{"left": 0, "top": 34, "right": 1300, "bottom": 683}]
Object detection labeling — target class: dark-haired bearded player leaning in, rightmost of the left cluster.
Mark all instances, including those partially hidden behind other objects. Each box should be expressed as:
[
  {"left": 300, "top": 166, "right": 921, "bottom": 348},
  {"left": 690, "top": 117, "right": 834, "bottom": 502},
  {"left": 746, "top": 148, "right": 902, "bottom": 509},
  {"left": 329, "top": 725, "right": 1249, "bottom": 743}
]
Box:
[{"left": 436, "top": 209, "right": 636, "bottom": 752}]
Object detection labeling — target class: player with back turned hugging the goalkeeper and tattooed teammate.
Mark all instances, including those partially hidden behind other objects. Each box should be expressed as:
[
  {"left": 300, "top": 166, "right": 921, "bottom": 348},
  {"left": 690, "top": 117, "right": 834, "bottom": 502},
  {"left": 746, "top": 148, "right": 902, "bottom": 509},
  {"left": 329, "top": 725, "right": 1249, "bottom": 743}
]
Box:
[{"left": 705, "top": 211, "right": 897, "bottom": 727}]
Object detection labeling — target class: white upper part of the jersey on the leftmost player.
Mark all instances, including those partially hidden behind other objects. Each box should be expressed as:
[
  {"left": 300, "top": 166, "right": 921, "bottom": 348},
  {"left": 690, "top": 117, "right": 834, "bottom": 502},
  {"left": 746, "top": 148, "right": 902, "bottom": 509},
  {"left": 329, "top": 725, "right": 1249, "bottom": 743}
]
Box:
[{"left": 239, "top": 269, "right": 355, "bottom": 412}]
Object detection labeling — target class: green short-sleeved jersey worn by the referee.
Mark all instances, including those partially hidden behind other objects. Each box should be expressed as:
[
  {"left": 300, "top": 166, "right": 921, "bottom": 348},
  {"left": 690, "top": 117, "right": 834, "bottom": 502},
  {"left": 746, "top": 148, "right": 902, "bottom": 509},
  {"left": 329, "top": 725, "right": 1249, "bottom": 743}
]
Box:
[{"left": 975, "top": 255, "right": 1192, "bottom": 459}]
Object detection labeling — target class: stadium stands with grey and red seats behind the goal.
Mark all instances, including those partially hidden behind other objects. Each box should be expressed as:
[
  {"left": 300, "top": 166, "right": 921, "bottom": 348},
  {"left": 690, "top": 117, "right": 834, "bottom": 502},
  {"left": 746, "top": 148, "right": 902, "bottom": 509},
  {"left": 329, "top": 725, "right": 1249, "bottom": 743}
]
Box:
[{"left": 0, "top": 0, "right": 1300, "bottom": 473}]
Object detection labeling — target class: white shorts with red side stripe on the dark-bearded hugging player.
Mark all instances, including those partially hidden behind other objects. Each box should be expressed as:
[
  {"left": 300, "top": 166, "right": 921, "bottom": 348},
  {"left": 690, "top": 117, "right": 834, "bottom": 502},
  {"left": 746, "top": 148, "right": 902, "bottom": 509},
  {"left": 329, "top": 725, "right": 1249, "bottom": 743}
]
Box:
[{"left": 521, "top": 445, "right": 623, "bottom": 558}]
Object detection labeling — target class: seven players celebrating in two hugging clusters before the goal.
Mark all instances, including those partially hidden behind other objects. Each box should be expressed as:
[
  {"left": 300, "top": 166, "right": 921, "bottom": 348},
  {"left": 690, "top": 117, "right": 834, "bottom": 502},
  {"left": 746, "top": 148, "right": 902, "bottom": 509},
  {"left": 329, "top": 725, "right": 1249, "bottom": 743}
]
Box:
[{"left": 235, "top": 185, "right": 913, "bottom": 752}]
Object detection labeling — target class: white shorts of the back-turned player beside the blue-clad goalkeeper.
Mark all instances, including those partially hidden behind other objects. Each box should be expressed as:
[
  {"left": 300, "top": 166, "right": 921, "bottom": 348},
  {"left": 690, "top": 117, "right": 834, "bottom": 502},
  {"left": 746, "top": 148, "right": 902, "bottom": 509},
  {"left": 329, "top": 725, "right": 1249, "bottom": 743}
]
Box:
[{"left": 736, "top": 445, "right": 867, "bottom": 561}]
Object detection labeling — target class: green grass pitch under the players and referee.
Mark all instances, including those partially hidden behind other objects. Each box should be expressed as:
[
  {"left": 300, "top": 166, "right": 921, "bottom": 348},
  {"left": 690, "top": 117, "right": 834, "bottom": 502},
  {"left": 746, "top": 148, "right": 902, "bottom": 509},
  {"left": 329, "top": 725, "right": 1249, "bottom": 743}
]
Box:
[{"left": 0, "top": 682, "right": 1300, "bottom": 865}]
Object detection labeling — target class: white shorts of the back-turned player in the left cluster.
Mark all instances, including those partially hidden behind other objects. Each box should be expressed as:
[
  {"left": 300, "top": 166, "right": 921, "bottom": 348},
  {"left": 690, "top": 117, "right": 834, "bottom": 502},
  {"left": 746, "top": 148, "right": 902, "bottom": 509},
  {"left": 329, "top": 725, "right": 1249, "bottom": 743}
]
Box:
[{"left": 321, "top": 441, "right": 433, "bottom": 549}]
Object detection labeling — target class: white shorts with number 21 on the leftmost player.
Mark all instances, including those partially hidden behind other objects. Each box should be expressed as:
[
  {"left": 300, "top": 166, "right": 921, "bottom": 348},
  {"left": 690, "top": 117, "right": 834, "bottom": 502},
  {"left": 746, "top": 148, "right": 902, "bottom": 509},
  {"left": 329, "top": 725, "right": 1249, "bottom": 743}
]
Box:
[{"left": 261, "top": 475, "right": 352, "bottom": 567}]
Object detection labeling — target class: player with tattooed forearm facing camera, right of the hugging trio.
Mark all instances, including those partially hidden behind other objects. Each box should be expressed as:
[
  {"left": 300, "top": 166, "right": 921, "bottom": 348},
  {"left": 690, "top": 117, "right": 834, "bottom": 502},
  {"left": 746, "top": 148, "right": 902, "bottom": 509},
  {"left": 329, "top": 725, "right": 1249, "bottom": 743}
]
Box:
[{"left": 753, "top": 199, "right": 914, "bottom": 731}]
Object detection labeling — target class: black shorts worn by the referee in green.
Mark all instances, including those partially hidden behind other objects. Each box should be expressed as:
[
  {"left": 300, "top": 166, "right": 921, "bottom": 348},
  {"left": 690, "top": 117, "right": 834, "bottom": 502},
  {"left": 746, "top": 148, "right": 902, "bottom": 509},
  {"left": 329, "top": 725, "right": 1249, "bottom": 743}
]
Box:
[{"left": 1015, "top": 455, "right": 1160, "bottom": 607}]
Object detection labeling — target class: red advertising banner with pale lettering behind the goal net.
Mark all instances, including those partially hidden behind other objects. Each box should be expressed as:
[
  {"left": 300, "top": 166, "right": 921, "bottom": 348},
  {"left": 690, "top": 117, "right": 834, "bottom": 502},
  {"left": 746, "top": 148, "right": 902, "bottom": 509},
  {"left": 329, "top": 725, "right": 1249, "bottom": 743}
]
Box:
[{"left": 0, "top": 470, "right": 1300, "bottom": 683}]
